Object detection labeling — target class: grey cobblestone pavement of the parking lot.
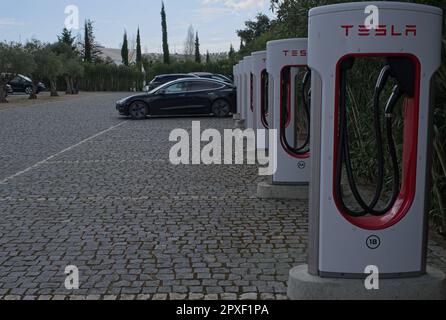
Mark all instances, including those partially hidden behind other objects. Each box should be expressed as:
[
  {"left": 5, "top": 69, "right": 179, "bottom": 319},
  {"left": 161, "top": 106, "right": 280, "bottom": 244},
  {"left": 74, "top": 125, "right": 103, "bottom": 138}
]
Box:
[{"left": 0, "top": 94, "right": 446, "bottom": 300}]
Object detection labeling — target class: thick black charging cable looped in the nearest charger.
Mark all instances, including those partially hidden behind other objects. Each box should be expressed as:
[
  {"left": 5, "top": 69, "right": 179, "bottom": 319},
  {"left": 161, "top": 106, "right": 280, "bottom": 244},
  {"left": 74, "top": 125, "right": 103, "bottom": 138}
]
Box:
[{"left": 335, "top": 58, "right": 415, "bottom": 217}]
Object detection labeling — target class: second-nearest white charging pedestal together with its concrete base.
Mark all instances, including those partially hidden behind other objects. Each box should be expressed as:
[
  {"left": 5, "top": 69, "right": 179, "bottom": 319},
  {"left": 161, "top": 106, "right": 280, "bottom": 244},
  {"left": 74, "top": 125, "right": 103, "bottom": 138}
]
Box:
[{"left": 257, "top": 39, "right": 310, "bottom": 200}]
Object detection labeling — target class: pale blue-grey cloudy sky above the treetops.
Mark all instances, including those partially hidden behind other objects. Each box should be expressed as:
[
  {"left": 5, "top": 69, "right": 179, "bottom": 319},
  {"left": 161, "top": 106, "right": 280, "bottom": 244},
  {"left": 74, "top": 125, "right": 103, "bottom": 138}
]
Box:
[{"left": 0, "top": 0, "right": 273, "bottom": 53}]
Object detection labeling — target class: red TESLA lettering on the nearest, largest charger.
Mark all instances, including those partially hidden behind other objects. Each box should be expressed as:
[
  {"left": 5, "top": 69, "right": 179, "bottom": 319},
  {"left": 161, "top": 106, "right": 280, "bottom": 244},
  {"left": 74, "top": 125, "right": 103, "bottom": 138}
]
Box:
[{"left": 341, "top": 24, "right": 417, "bottom": 37}]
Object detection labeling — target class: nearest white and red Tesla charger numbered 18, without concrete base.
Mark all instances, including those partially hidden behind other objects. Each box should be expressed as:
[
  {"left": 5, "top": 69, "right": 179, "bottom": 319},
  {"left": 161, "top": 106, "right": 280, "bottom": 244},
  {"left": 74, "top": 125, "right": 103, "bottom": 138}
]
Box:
[{"left": 296, "top": 2, "right": 442, "bottom": 288}]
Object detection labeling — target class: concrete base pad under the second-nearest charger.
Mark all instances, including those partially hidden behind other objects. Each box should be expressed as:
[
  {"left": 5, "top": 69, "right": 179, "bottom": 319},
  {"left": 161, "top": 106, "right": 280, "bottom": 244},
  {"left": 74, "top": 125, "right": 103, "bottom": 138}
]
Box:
[{"left": 257, "top": 182, "right": 309, "bottom": 200}]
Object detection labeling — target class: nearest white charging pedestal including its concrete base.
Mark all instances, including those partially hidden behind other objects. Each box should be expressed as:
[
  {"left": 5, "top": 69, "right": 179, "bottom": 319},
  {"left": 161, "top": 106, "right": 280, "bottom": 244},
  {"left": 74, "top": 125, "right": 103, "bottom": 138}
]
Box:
[{"left": 288, "top": 2, "right": 446, "bottom": 300}]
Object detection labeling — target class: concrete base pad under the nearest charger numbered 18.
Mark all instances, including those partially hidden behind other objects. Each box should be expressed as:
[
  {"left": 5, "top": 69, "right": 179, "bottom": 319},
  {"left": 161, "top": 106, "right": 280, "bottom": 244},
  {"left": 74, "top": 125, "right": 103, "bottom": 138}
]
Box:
[{"left": 288, "top": 265, "right": 446, "bottom": 300}]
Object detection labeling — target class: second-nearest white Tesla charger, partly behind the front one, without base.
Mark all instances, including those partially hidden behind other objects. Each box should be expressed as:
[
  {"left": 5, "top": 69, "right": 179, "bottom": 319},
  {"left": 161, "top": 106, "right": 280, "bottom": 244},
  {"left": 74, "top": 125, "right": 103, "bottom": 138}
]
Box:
[{"left": 267, "top": 39, "right": 310, "bottom": 198}]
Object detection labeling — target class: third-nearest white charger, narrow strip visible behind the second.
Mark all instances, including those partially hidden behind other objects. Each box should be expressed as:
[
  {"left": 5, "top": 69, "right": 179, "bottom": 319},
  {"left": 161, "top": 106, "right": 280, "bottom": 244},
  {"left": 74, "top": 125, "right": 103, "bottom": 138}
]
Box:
[{"left": 252, "top": 51, "right": 268, "bottom": 149}]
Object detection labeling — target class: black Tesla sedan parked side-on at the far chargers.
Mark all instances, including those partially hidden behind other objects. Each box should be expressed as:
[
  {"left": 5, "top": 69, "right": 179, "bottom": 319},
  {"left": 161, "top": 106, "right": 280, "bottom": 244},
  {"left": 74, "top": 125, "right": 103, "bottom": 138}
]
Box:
[{"left": 116, "top": 78, "right": 236, "bottom": 119}]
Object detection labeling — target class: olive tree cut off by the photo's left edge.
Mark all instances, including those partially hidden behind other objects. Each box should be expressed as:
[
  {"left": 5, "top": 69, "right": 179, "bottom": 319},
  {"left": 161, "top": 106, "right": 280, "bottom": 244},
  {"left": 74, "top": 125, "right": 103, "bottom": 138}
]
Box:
[{"left": 0, "top": 42, "right": 36, "bottom": 103}]
